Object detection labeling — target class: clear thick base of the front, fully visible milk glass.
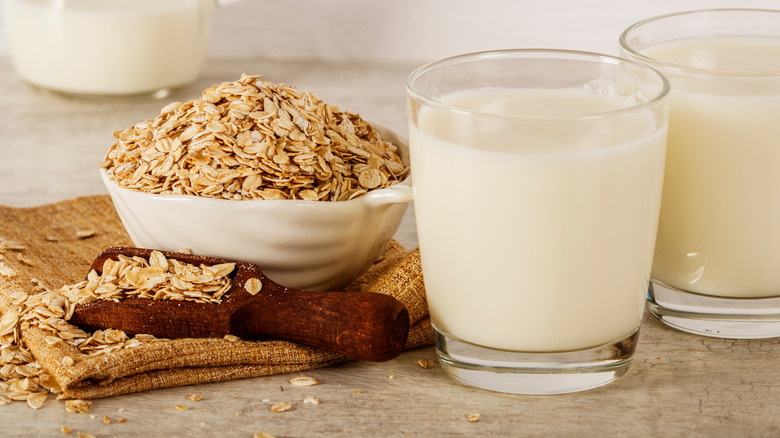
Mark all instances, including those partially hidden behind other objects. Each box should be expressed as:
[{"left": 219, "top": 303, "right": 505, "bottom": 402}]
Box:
[{"left": 433, "top": 326, "right": 639, "bottom": 395}]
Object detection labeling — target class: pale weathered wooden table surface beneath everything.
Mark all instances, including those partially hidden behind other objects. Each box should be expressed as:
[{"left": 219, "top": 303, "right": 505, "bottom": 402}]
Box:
[{"left": 0, "top": 58, "right": 780, "bottom": 437}]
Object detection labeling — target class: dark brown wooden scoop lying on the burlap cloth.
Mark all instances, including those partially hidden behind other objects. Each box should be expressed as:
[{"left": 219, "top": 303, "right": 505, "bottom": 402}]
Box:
[{"left": 70, "top": 247, "right": 409, "bottom": 362}]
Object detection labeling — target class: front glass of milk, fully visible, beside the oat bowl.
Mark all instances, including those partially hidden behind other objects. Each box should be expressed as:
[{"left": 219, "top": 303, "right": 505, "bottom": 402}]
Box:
[{"left": 407, "top": 50, "right": 669, "bottom": 394}]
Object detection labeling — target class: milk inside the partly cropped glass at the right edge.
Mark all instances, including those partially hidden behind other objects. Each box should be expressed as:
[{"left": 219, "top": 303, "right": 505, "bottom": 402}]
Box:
[{"left": 644, "top": 37, "right": 780, "bottom": 297}]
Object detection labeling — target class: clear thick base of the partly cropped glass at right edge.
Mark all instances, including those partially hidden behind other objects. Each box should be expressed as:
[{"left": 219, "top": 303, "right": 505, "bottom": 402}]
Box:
[{"left": 647, "top": 280, "right": 780, "bottom": 339}]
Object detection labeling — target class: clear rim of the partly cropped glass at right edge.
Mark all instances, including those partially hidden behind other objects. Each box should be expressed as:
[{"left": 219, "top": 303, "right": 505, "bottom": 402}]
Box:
[{"left": 618, "top": 8, "right": 780, "bottom": 80}]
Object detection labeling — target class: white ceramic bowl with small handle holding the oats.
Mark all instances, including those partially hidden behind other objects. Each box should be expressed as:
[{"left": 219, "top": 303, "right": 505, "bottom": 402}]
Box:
[{"left": 100, "top": 124, "right": 412, "bottom": 290}]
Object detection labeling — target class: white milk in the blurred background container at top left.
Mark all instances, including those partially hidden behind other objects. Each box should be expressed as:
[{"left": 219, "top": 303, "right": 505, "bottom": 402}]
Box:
[{"left": 5, "top": 0, "right": 213, "bottom": 94}]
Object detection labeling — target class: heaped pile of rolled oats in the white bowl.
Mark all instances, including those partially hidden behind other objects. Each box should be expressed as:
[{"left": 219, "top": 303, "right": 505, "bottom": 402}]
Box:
[{"left": 100, "top": 75, "right": 409, "bottom": 201}]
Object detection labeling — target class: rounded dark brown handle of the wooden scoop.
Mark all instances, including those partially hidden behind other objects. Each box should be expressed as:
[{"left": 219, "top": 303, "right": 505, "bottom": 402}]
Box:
[{"left": 230, "top": 285, "right": 409, "bottom": 362}]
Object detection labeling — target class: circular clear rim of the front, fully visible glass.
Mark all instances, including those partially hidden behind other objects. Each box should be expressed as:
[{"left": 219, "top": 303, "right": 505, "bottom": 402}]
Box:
[{"left": 406, "top": 48, "right": 671, "bottom": 121}]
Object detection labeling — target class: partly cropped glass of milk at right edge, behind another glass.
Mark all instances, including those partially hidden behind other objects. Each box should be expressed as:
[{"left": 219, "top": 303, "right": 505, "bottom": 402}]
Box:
[{"left": 620, "top": 9, "right": 780, "bottom": 338}]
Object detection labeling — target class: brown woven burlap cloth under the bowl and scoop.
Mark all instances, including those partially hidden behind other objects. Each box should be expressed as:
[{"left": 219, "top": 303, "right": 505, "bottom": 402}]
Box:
[{"left": 0, "top": 196, "right": 433, "bottom": 399}]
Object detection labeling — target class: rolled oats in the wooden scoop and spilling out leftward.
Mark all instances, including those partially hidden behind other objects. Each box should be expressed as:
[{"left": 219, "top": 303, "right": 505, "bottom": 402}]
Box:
[{"left": 0, "top": 252, "right": 238, "bottom": 413}]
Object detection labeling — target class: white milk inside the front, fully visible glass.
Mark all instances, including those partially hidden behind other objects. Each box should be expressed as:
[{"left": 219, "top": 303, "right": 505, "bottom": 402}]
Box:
[{"left": 410, "top": 90, "right": 666, "bottom": 352}]
